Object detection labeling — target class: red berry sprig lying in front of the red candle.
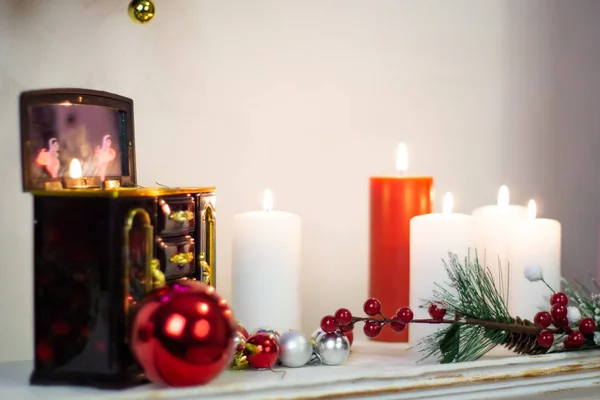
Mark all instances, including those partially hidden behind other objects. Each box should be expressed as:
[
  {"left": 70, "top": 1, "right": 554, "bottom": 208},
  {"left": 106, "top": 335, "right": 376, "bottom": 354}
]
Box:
[{"left": 321, "top": 298, "right": 446, "bottom": 339}]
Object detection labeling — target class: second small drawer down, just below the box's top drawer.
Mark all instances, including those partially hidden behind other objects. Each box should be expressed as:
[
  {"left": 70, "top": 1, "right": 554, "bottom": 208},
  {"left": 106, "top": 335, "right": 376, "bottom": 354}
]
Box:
[{"left": 156, "top": 236, "right": 196, "bottom": 280}]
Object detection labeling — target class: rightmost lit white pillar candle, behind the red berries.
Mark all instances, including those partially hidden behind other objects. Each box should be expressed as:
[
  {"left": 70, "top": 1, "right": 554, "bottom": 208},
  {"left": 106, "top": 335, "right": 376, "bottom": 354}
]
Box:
[{"left": 508, "top": 200, "right": 561, "bottom": 321}]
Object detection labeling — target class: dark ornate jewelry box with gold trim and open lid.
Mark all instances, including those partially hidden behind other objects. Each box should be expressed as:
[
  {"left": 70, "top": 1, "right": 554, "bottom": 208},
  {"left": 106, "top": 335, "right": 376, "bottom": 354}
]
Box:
[{"left": 20, "top": 89, "right": 216, "bottom": 387}]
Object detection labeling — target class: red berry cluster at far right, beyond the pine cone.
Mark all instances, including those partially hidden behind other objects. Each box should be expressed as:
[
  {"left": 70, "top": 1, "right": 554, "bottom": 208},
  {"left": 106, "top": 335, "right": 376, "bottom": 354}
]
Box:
[{"left": 533, "top": 292, "right": 596, "bottom": 349}]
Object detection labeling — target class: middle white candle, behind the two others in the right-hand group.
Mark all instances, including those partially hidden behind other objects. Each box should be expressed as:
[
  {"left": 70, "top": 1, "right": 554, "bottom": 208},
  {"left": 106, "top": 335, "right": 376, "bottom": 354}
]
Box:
[{"left": 471, "top": 186, "right": 527, "bottom": 287}]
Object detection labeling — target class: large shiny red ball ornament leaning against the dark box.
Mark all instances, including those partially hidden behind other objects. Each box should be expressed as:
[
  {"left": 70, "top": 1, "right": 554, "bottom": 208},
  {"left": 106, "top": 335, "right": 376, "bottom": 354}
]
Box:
[{"left": 131, "top": 281, "right": 237, "bottom": 386}]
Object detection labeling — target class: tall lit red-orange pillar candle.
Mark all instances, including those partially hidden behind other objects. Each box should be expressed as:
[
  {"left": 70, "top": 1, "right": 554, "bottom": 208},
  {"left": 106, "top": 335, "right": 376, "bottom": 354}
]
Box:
[{"left": 369, "top": 143, "right": 434, "bottom": 342}]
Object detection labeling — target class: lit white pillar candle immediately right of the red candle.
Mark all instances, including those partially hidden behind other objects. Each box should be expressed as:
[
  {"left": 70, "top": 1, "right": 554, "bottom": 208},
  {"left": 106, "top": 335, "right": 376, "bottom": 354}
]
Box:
[{"left": 410, "top": 193, "right": 475, "bottom": 346}]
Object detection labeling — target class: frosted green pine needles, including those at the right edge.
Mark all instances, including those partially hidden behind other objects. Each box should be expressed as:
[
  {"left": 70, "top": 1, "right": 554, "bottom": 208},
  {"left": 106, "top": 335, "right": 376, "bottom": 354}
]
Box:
[{"left": 417, "top": 253, "right": 600, "bottom": 364}]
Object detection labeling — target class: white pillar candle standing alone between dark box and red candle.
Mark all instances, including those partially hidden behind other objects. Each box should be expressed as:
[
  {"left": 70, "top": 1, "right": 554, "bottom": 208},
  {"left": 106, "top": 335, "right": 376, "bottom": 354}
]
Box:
[{"left": 232, "top": 190, "right": 301, "bottom": 332}]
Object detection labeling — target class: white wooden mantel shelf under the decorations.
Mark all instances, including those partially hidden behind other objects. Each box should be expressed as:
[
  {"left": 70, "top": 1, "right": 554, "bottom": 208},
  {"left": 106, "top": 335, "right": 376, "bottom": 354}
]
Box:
[{"left": 0, "top": 342, "right": 600, "bottom": 400}]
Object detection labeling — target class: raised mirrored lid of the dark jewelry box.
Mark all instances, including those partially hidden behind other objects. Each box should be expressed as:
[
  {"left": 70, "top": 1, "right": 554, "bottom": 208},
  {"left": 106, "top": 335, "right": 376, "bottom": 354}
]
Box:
[{"left": 21, "top": 89, "right": 135, "bottom": 191}]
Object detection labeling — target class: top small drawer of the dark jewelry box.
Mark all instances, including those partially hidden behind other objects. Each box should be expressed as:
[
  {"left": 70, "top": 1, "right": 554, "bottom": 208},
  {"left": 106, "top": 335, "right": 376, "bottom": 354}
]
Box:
[{"left": 157, "top": 195, "right": 196, "bottom": 235}]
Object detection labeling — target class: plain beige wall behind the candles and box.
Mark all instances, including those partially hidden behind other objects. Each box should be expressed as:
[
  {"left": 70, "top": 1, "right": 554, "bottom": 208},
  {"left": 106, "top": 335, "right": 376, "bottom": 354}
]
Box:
[{"left": 0, "top": 0, "right": 600, "bottom": 360}]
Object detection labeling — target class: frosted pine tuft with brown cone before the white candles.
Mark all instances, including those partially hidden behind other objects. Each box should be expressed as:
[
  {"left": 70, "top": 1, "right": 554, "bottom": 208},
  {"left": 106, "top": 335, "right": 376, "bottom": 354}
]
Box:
[{"left": 415, "top": 253, "right": 548, "bottom": 363}]
